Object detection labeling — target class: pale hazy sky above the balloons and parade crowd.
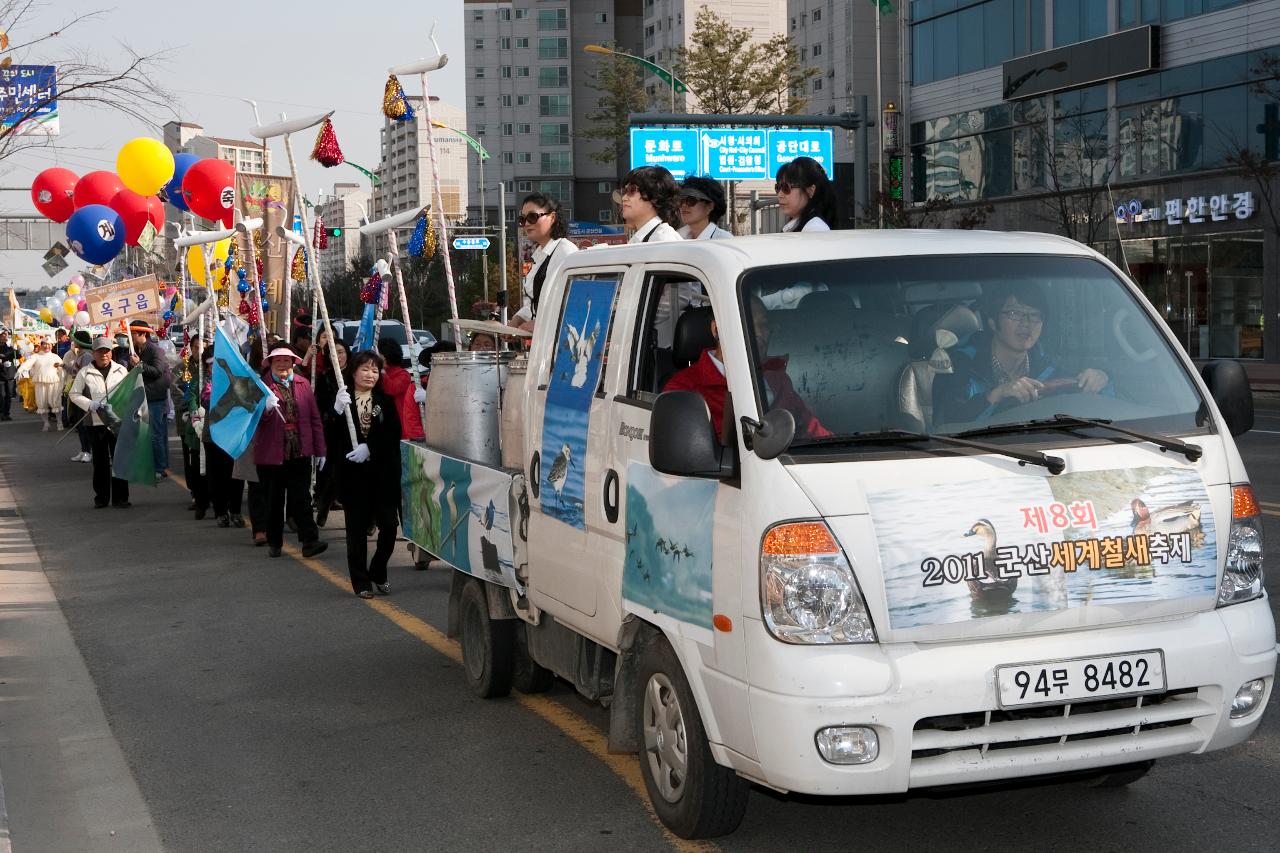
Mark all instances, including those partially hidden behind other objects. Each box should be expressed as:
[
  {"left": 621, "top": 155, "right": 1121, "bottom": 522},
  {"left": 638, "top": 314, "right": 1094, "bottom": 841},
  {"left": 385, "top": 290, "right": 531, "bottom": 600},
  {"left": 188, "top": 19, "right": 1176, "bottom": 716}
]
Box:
[{"left": 0, "top": 0, "right": 465, "bottom": 212}]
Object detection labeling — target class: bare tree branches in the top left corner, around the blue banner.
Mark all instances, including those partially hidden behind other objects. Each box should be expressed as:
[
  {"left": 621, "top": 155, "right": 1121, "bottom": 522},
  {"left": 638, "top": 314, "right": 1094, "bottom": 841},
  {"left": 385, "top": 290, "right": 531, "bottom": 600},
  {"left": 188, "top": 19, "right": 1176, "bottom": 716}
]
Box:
[{"left": 0, "top": 0, "right": 173, "bottom": 160}]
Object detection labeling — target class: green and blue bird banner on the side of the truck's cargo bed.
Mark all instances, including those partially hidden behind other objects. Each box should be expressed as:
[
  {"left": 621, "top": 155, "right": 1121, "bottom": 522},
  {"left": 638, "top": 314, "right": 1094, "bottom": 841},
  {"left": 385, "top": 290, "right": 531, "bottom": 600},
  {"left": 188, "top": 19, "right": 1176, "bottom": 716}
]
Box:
[{"left": 401, "top": 442, "right": 529, "bottom": 589}]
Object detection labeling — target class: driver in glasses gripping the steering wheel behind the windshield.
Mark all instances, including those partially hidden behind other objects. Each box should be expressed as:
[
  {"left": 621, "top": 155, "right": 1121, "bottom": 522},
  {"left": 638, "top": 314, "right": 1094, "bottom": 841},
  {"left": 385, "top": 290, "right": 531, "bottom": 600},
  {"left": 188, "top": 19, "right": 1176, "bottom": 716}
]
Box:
[{"left": 933, "top": 282, "right": 1111, "bottom": 424}]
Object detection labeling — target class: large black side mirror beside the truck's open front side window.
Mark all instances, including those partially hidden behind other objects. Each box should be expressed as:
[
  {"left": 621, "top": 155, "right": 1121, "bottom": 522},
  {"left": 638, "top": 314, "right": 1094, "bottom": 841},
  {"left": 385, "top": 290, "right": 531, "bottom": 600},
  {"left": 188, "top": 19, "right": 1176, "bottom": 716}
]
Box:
[{"left": 649, "top": 391, "right": 735, "bottom": 480}]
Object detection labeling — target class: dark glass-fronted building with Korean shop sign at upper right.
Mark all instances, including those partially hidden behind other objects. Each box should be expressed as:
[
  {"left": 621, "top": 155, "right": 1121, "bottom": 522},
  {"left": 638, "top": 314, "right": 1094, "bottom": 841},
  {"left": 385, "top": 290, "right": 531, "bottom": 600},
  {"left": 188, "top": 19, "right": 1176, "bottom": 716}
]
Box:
[{"left": 906, "top": 0, "right": 1280, "bottom": 371}]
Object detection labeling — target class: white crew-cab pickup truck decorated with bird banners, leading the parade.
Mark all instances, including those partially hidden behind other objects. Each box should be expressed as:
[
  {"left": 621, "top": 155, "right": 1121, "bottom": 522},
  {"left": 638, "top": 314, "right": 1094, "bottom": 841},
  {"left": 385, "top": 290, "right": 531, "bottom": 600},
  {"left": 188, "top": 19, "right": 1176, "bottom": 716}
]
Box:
[{"left": 403, "top": 231, "right": 1276, "bottom": 838}]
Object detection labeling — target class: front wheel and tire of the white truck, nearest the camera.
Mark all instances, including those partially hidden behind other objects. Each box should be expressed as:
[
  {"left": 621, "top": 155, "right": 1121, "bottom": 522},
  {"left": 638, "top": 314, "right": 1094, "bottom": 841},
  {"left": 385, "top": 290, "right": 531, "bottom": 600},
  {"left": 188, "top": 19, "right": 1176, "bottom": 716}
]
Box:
[{"left": 637, "top": 637, "right": 750, "bottom": 839}]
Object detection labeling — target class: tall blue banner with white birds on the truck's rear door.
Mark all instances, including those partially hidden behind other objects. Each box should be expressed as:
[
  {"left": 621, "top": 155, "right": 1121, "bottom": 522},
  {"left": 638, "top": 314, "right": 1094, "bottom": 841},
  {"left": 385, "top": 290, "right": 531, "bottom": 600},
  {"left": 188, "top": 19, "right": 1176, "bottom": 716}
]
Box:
[{"left": 538, "top": 279, "right": 618, "bottom": 530}]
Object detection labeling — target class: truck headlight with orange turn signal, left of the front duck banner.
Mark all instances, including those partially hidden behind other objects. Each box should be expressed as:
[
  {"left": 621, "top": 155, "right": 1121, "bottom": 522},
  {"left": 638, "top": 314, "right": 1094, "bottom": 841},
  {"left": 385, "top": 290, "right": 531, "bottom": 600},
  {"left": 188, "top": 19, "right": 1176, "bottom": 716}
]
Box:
[{"left": 760, "top": 521, "right": 876, "bottom": 643}]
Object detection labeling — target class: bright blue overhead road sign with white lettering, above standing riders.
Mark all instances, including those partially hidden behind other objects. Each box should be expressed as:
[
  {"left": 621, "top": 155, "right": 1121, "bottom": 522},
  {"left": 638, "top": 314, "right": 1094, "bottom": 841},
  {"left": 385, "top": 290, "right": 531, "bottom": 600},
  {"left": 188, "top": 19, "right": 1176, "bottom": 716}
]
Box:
[{"left": 631, "top": 127, "right": 835, "bottom": 181}]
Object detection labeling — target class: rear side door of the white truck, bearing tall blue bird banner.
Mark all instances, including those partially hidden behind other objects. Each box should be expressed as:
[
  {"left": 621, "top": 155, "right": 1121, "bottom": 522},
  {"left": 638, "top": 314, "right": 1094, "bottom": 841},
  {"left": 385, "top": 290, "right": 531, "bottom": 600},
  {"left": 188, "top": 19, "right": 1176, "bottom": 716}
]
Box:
[{"left": 526, "top": 266, "right": 626, "bottom": 616}]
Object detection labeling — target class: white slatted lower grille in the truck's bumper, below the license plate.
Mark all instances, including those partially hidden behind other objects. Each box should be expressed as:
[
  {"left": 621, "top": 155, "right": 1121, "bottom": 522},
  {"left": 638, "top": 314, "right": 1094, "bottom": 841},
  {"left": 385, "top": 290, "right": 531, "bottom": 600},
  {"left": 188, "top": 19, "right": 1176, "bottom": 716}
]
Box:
[{"left": 911, "top": 688, "right": 1217, "bottom": 785}]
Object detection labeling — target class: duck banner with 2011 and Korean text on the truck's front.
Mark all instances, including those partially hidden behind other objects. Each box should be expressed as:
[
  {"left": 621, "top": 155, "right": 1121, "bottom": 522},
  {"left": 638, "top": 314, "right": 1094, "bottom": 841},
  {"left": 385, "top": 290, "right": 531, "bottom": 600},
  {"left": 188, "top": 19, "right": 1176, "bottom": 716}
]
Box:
[{"left": 867, "top": 467, "right": 1217, "bottom": 629}]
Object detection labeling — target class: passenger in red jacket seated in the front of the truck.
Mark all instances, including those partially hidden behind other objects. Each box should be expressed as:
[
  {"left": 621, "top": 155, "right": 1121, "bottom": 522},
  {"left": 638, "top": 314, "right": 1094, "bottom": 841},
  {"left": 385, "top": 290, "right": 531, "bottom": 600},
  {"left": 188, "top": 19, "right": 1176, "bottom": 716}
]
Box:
[{"left": 663, "top": 300, "right": 831, "bottom": 438}]
